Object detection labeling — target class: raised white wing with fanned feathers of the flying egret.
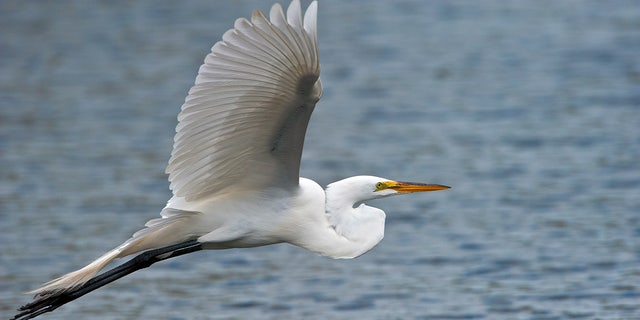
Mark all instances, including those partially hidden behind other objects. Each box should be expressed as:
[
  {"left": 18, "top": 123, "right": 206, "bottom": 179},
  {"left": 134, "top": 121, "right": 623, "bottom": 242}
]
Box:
[{"left": 166, "top": 0, "right": 322, "bottom": 201}]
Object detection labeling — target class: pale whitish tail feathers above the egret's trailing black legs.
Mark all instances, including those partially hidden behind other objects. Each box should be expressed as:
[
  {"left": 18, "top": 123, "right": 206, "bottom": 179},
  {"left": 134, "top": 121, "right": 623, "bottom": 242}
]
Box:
[{"left": 26, "top": 208, "right": 198, "bottom": 299}]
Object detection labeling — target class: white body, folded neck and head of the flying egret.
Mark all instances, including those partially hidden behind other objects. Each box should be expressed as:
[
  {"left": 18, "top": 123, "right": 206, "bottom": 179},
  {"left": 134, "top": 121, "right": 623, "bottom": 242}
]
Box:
[{"left": 162, "top": 176, "right": 385, "bottom": 258}]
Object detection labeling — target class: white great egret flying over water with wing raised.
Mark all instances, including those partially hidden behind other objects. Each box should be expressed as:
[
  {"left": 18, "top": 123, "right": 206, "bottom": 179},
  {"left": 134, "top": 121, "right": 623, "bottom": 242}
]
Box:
[{"left": 15, "top": 0, "right": 449, "bottom": 319}]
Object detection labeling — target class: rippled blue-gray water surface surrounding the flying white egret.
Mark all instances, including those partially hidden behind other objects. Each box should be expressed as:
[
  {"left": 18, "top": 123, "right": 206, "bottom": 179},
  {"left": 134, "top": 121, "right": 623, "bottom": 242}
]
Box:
[{"left": 0, "top": 0, "right": 640, "bottom": 319}]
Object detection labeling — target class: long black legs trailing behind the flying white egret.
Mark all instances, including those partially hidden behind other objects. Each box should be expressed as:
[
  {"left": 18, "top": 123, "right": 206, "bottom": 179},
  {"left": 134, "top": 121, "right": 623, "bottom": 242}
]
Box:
[{"left": 12, "top": 240, "right": 202, "bottom": 320}]
